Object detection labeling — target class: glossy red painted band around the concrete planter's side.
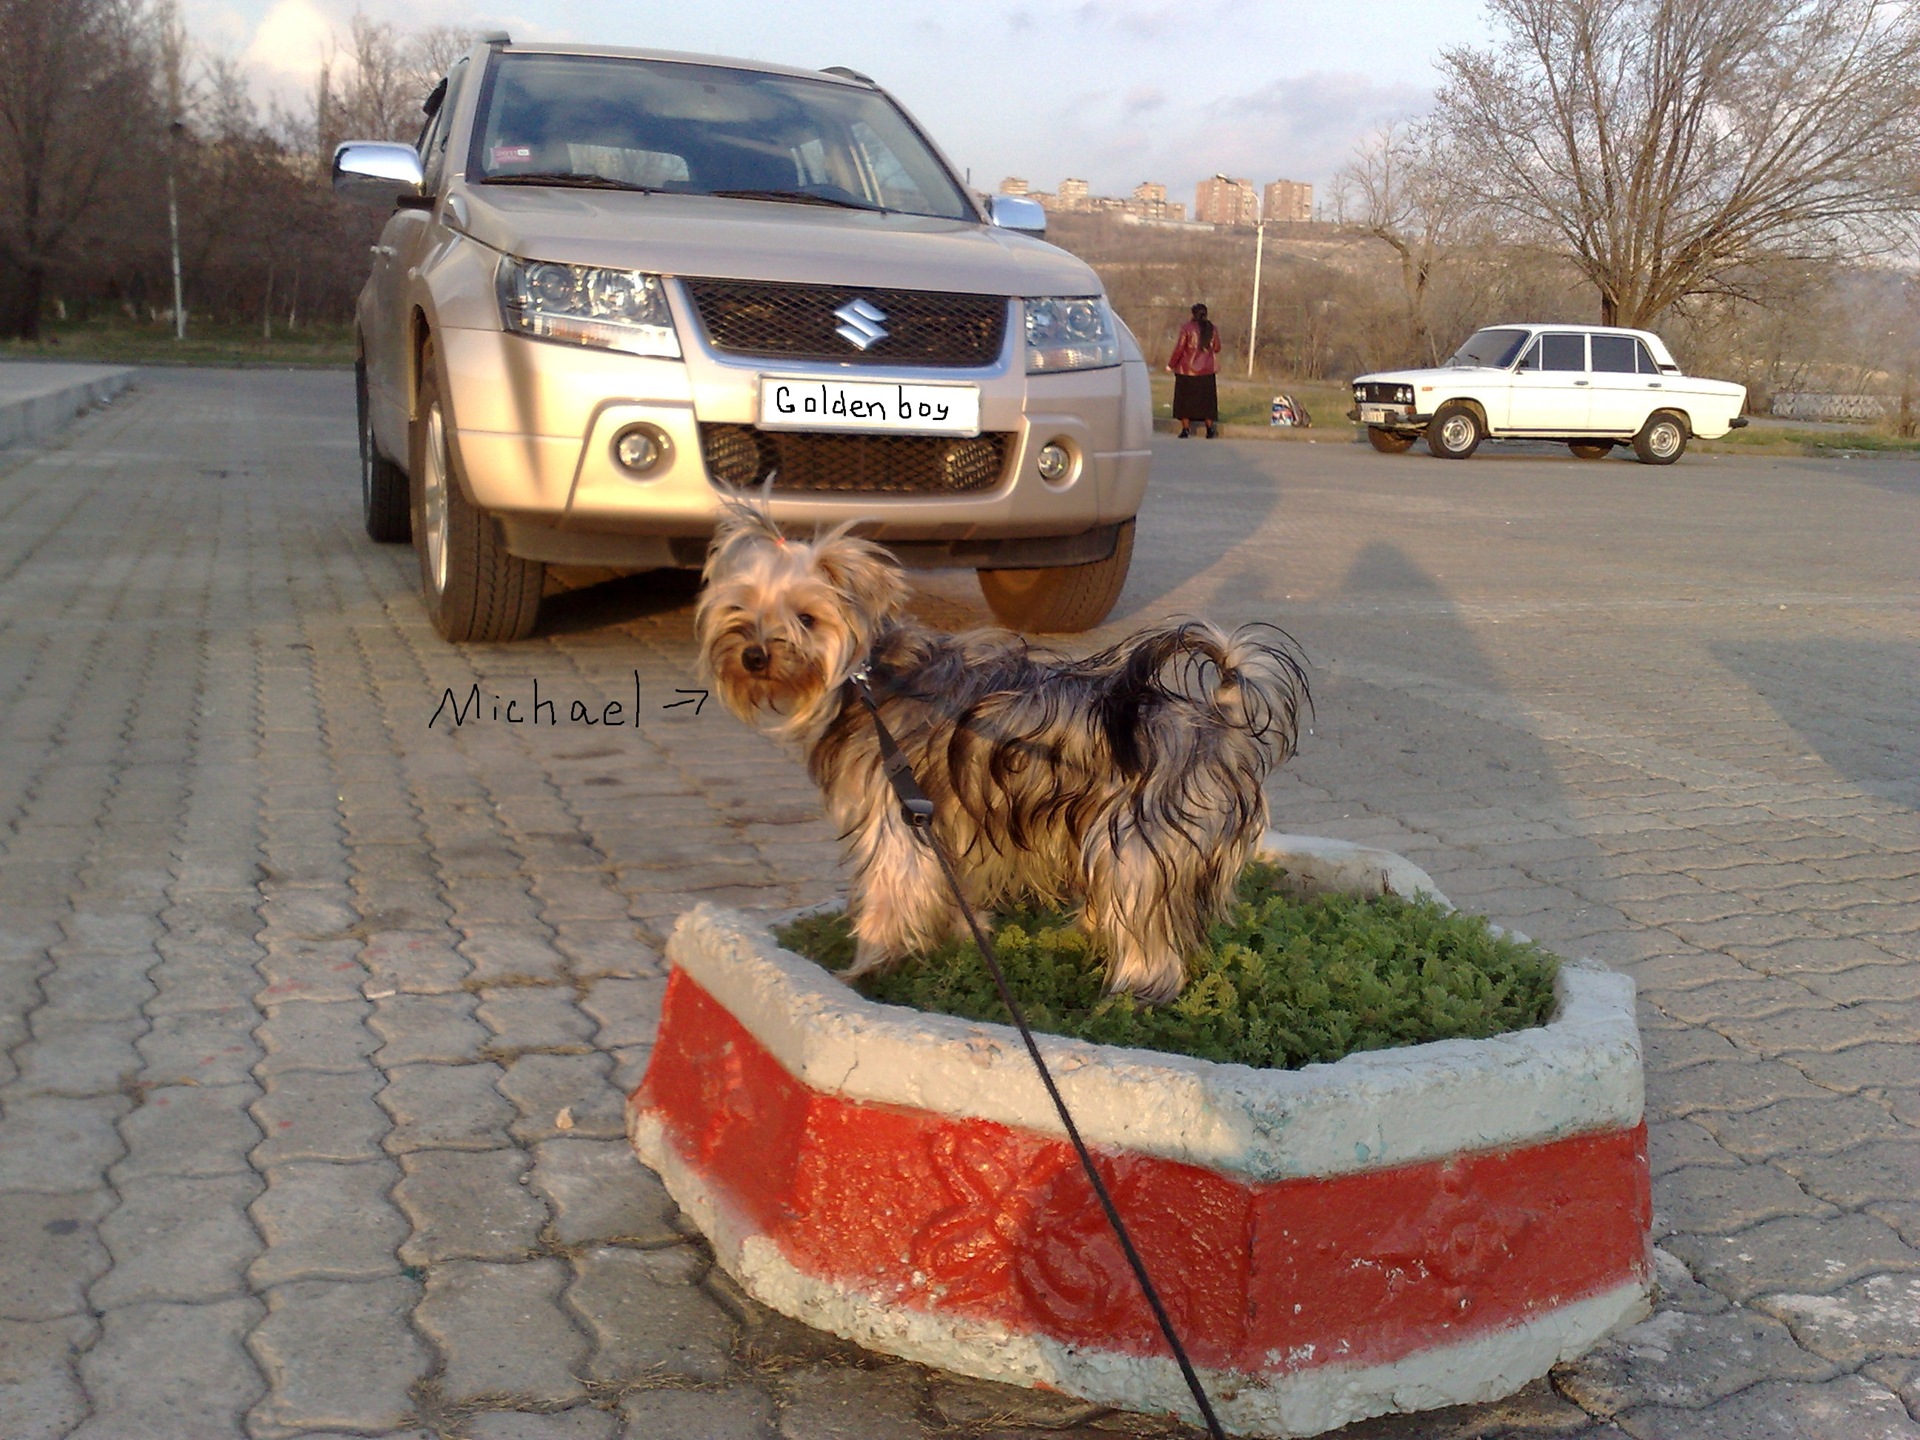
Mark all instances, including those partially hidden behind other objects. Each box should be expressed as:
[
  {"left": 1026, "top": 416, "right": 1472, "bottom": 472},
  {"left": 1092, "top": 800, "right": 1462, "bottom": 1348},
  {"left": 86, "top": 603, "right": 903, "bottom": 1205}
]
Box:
[{"left": 634, "top": 968, "right": 1651, "bottom": 1373}]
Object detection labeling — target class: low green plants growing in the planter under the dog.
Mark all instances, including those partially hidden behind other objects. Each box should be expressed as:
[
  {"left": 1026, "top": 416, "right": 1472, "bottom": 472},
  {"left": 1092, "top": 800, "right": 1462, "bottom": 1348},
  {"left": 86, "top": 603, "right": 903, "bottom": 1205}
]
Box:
[{"left": 776, "top": 862, "right": 1559, "bottom": 1069}]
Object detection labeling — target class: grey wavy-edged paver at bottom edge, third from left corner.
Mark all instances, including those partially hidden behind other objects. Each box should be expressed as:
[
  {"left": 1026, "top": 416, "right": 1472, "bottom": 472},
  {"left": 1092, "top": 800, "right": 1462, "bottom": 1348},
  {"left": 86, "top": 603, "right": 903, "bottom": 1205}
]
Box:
[{"left": 248, "top": 1277, "right": 432, "bottom": 1436}]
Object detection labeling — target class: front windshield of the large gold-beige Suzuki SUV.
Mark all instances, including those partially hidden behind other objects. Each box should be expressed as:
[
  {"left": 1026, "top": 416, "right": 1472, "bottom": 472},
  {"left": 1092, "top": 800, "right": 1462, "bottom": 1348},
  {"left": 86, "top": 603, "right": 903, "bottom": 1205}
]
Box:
[{"left": 467, "top": 54, "right": 979, "bottom": 221}]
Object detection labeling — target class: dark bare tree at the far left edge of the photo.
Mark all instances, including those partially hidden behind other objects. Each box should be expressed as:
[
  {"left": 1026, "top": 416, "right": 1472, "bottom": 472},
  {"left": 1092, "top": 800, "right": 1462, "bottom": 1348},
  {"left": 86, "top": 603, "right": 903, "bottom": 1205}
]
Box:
[{"left": 0, "top": 0, "right": 154, "bottom": 340}]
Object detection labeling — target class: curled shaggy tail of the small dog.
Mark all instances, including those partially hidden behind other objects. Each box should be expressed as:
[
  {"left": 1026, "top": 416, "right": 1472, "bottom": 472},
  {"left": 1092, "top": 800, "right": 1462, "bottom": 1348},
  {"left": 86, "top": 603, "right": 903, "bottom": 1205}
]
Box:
[{"left": 1108, "top": 620, "right": 1313, "bottom": 764}]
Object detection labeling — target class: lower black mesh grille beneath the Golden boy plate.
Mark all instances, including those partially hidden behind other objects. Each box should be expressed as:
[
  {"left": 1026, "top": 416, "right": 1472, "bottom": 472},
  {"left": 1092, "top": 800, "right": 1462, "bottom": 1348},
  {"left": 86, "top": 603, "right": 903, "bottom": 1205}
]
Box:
[{"left": 701, "top": 424, "right": 1012, "bottom": 495}]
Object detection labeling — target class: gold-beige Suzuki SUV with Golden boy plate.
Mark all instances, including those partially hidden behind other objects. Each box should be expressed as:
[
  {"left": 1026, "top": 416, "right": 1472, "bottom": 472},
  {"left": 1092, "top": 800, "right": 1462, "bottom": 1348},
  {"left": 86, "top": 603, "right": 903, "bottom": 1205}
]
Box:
[{"left": 334, "top": 36, "right": 1152, "bottom": 639}]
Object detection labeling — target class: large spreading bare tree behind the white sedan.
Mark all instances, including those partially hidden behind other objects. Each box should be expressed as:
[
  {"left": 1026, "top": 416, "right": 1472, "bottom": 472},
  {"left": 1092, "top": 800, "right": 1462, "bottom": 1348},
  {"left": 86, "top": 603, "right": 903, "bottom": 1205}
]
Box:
[{"left": 1434, "top": 0, "right": 1920, "bottom": 324}]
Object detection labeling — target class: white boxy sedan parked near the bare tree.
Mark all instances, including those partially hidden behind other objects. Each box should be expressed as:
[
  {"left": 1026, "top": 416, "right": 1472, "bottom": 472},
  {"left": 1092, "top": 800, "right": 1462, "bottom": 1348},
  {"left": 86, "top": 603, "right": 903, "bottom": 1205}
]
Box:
[{"left": 1348, "top": 324, "right": 1747, "bottom": 465}]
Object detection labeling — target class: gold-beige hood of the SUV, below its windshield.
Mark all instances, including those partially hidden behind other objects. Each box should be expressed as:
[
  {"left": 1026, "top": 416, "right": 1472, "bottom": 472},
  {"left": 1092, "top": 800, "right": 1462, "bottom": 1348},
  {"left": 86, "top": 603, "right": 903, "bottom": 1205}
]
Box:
[{"left": 455, "top": 184, "right": 1104, "bottom": 296}]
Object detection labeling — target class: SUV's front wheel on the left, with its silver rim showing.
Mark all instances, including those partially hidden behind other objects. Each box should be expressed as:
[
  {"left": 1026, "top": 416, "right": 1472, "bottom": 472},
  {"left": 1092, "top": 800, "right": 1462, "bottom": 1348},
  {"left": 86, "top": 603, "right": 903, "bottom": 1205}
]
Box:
[{"left": 409, "top": 340, "right": 547, "bottom": 643}]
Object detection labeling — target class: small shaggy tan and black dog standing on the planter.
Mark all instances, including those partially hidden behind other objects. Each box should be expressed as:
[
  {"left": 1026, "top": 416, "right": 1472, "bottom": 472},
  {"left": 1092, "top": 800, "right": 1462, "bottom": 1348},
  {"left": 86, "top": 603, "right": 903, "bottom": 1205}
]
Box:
[{"left": 695, "top": 503, "right": 1311, "bottom": 1002}]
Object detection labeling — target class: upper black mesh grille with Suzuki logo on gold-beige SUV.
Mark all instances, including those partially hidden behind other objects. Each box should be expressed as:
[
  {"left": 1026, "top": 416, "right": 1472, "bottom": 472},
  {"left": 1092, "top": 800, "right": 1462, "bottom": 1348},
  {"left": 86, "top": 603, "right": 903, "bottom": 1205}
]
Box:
[{"left": 684, "top": 280, "right": 1006, "bottom": 367}]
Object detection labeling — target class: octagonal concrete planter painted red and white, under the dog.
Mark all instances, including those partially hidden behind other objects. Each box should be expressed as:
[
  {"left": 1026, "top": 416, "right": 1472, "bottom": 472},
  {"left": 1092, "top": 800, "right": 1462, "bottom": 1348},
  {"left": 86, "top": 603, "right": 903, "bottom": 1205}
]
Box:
[{"left": 628, "top": 833, "right": 1651, "bottom": 1436}]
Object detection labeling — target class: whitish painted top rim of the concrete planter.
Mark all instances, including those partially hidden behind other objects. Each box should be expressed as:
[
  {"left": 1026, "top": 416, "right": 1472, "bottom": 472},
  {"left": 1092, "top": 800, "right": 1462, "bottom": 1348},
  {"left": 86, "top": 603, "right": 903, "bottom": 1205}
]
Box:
[{"left": 666, "top": 831, "right": 1644, "bottom": 1181}]
